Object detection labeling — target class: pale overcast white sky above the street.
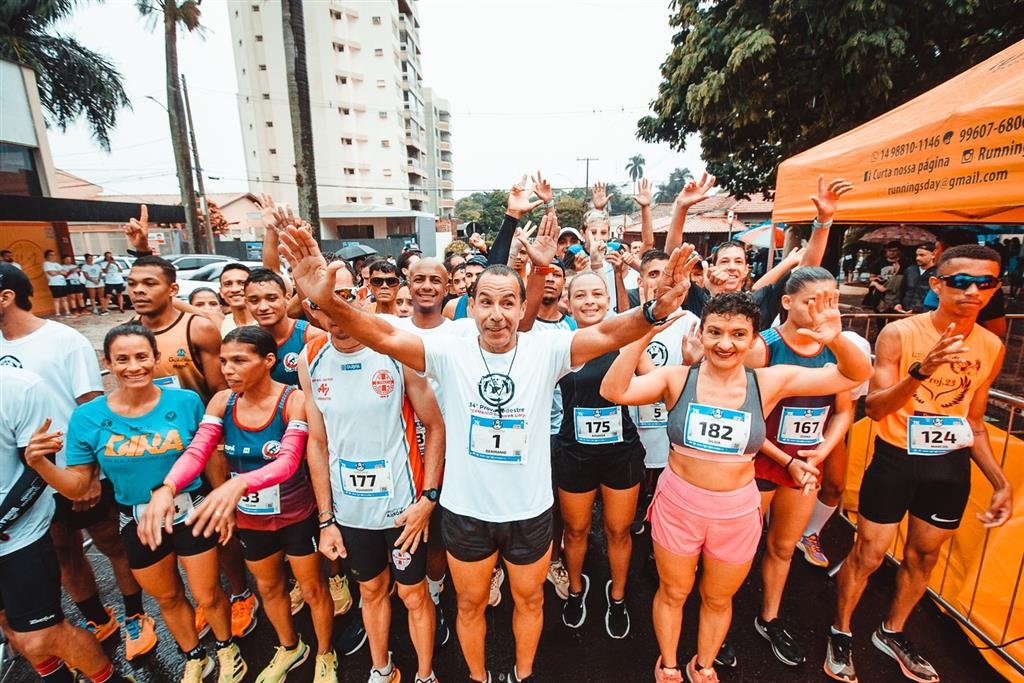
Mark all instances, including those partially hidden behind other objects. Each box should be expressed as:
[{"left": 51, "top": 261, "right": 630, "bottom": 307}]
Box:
[{"left": 50, "top": 0, "right": 703, "bottom": 197}]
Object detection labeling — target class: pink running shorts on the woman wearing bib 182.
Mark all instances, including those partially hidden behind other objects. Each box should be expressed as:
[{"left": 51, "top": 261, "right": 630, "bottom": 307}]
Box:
[{"left": 647, "top": 467, "right": 762, "bottom": 564}]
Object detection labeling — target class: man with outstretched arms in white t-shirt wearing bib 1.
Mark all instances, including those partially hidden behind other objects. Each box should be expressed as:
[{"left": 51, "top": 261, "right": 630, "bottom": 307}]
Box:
[{"left": 281, "top": 220, "right": 692, "bottom": 683}]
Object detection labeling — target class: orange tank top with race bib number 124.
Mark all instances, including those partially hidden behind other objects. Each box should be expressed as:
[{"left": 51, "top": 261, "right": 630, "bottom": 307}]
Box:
[{"left": 878, "top": 313, "right": 1002, "bottom": 455}]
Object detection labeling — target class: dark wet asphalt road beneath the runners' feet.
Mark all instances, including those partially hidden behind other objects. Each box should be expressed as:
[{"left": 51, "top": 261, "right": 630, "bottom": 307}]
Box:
[{"left": 0, "top": 509, "right": 1002, "bottom": 683}]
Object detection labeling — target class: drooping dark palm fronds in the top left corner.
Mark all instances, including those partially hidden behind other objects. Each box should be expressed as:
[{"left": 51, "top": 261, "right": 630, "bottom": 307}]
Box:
[{"left": 0, "top": 0, "right": 131, "bottom": 152}]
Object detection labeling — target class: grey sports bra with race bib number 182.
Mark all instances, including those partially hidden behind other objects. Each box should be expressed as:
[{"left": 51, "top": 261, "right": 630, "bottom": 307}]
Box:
[{"left": 669, "top": 366, "right": 766, "bottom": 463}]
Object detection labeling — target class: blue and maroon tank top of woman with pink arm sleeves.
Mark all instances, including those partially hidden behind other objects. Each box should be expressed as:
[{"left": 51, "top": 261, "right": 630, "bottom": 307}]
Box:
[{"left": 224, "top": 386, "right": 315, "bottom": 529}]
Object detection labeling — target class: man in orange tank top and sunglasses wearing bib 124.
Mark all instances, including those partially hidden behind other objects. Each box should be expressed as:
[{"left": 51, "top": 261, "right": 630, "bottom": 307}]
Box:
[{"left": 824, "top": 245, "right": 1012, "bottom": 682}]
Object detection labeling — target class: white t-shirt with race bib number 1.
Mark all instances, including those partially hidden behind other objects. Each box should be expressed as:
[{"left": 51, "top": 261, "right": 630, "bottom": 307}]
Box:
[{"left": 423, "top": 331, "right": 574, "bottom": 522}]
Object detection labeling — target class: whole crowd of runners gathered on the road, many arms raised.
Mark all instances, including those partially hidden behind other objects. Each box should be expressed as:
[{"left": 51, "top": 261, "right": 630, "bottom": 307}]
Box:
[{"left": 0, "top": 173, "right": 1007, "bottom": 683}]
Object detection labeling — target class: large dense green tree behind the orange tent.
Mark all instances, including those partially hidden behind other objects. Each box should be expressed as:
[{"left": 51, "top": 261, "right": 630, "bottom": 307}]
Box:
[{"left": 638, "top": 0, "right": 1024, "bottom": 196}]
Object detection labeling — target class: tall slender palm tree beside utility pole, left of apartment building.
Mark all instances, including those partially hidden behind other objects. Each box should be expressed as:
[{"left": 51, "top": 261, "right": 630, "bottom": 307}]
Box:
[{"left": 135, "top": 0, "right": 205, "bottom": 251}]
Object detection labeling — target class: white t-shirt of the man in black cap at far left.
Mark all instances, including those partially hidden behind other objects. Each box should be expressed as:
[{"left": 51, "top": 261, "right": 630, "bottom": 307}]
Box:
[{"left": 0, "top": 321, "right": 103, "bottom": 467}]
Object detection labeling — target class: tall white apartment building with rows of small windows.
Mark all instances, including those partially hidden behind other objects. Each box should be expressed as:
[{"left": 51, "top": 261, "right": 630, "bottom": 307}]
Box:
[{"left": 228, "top": 0, "right": 454, "bottom": 239}]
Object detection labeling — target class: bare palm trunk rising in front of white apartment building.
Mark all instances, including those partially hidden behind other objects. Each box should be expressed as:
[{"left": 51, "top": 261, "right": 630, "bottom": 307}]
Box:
[{"left": 281, "top": 0, "right": 321, "bottom": 241}]
